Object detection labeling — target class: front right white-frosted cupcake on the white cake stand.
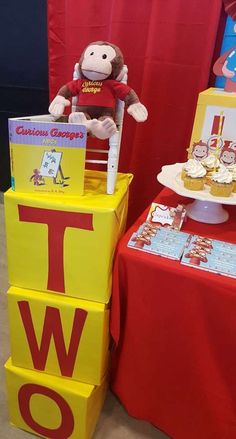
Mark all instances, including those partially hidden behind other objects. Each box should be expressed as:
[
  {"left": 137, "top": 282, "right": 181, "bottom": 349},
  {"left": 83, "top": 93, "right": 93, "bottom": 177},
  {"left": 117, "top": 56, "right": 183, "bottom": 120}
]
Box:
[{"left": 210, "top": 165, "right": 233, "bottom": 197}]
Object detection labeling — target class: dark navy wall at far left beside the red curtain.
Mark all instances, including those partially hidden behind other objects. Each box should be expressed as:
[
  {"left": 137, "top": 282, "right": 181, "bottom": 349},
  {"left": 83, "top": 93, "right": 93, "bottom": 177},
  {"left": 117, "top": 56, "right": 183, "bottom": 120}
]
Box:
[{"left": 0, "top": 0, "right": 48, "bottom": 191}]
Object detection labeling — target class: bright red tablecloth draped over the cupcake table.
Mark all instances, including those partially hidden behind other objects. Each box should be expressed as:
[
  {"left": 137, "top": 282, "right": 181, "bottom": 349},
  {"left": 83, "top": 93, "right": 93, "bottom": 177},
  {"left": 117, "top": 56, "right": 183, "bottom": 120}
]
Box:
[{"left": 111, "top": 189, "right": 236, "bottom": 439}]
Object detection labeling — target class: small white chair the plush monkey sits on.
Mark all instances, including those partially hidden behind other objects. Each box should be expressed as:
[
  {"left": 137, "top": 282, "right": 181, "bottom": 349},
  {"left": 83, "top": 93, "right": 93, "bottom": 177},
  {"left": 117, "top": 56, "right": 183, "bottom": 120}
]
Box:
[{"left": 71, "top": 63, "right": 128, "bottom": 195}]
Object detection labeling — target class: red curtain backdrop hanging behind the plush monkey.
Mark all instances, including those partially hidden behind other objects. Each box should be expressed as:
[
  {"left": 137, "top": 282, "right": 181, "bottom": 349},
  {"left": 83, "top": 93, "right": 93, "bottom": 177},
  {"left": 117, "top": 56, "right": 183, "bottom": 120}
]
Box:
[{"left": 48, "top": 0, "right": 222, "bottom": 222}]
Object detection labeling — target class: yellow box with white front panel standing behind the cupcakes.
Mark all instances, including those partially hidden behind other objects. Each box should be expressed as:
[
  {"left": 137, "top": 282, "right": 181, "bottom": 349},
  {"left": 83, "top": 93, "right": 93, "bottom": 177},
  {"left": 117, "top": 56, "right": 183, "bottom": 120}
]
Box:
[{"left": 188, "top": 87, "right": 236, "bottom": 166}]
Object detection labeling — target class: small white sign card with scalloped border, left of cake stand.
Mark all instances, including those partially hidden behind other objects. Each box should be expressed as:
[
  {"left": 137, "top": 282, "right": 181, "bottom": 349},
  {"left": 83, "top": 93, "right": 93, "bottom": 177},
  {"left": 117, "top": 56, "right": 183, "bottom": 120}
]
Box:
[{"left": 147, "top": 203, "right": 186, "bottom": 230}]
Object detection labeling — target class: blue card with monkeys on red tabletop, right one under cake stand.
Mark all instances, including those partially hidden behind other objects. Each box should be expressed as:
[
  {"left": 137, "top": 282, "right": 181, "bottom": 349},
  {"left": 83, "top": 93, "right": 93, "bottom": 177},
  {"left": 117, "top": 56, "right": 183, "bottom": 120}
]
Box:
[{"left": 181, "top": 235, "right": 236, "bottom": 278}]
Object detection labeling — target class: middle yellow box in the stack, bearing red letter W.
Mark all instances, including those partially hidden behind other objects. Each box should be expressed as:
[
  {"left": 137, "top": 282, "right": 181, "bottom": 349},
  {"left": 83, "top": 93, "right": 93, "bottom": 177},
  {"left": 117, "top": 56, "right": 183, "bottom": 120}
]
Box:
[{"left": 8, "top": 287, "right": 109, "bottom": 385}]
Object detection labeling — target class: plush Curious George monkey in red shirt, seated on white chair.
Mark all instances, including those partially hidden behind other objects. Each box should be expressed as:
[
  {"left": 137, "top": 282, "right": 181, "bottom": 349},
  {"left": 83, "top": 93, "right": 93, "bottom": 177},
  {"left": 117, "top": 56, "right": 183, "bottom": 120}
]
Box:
[{"left": 49, "top": 41, "right": 148, "bottom": 139}]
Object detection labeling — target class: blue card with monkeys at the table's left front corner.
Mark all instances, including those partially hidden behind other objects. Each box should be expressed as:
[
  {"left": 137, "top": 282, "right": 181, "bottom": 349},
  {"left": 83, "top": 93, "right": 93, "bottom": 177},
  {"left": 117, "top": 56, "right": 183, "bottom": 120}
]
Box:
[{"left": 128, "top": 222, "right": 190, "bottom": 260}]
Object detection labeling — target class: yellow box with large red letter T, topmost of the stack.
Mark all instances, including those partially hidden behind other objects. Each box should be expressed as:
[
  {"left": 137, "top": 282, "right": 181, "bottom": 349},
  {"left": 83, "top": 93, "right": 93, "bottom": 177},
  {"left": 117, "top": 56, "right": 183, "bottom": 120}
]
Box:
[{"left": 5, "top": 171, "right": 132, "bottom": 303}]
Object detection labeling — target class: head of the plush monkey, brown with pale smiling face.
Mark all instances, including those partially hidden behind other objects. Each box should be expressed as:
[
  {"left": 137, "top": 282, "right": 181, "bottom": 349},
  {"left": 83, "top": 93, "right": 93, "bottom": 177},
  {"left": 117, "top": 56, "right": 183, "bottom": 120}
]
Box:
[{"left": 80, "top": 42, "right": 123, "bottom": 81}]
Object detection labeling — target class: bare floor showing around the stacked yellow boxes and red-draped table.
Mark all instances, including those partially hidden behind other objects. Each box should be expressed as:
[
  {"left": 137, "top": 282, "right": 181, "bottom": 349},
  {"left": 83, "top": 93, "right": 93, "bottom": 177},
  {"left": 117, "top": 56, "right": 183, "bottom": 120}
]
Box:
[{"left": 0, "top": 194, "right": 168, "bottom": 439}]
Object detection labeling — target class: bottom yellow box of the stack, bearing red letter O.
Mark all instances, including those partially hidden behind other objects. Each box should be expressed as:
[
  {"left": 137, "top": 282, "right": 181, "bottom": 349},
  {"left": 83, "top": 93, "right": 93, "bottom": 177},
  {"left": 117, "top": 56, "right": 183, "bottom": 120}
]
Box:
[{"left": 5, "top": 359, "right": 107, "bottom": 439}]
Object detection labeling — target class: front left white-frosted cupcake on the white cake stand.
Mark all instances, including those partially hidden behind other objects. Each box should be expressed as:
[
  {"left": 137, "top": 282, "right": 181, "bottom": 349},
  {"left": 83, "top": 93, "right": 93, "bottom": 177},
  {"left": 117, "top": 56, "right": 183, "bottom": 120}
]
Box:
[{"left": 183, "top": 160, "right": 206, "bottom": 191}]
